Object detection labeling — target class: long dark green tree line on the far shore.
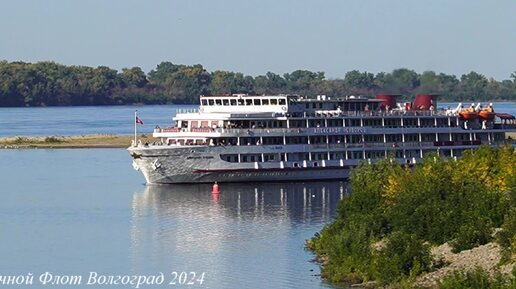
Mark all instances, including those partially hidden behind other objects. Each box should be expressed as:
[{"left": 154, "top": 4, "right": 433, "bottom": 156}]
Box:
[{"left": 0, "top": 61, "right": 516, "bottom": 106}]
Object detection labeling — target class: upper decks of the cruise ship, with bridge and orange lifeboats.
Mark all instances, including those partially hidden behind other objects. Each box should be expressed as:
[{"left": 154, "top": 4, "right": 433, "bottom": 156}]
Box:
[{"left": 160, "top": 94, "right": 515, "bottom": 137}]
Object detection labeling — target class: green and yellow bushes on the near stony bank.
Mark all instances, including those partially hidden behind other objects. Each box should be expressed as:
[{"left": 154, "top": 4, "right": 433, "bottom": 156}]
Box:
[{"left": 307, "top": 146, "right": 516, "bottom": 288}]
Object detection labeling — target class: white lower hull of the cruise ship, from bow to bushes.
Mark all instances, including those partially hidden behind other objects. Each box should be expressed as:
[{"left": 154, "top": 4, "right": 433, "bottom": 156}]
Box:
[{"left": 129, "top": 147, "right": 351, "bottom": 184}]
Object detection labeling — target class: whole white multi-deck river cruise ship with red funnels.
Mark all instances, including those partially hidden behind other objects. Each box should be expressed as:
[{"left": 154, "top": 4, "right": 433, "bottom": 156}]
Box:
[{"left": 128, "top": 94, "right": 516, "bottom": 184}]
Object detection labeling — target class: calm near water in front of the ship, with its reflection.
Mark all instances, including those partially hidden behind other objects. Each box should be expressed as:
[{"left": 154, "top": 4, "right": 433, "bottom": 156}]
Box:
[{"left": 0, "top": 149, "right": 345, "bottom": 288}]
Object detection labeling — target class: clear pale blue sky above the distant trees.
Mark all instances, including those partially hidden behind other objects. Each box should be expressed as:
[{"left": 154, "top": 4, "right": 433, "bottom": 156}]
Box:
[{"left": 0, "top": 0, "right": 516, "bottom": 80}]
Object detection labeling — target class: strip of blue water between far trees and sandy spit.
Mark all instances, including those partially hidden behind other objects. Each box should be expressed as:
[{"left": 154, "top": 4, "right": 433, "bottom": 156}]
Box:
[{"left": 0, "top": 105, "right": 197, "bottom": 137}]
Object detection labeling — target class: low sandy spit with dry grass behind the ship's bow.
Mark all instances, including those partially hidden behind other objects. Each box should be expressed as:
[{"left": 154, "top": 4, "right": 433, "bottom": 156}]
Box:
[{"left": 0, "top": 134, "right": 156, "bottom": 148}]
